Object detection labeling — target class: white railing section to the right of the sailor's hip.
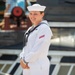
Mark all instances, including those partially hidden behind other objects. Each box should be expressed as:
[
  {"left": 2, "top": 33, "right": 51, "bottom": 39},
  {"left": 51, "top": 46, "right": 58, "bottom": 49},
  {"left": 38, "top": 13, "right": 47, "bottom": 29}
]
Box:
[{"left": 49, "top": 51, "right": 75, "bottom": 75}]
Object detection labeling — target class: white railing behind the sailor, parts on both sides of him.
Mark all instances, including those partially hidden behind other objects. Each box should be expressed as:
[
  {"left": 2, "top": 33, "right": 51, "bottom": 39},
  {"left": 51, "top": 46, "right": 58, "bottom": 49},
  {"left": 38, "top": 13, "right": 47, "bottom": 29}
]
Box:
[{"left": 0, "top": 49, "right": 75, "bottom": 75}]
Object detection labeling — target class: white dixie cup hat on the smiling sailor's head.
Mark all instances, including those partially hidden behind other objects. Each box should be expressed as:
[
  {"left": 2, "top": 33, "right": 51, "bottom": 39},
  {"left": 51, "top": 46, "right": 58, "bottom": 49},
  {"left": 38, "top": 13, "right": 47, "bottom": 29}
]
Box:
[{"left": 27, "top": 4, "right": 46, "bottom": 11}]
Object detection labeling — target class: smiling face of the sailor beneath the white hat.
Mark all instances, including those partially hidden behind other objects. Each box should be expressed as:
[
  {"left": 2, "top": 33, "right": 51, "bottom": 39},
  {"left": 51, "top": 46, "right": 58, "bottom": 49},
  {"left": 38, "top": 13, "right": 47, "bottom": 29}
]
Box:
[{"left": 29, "top": 11, "right": 44, "bottom": 24}]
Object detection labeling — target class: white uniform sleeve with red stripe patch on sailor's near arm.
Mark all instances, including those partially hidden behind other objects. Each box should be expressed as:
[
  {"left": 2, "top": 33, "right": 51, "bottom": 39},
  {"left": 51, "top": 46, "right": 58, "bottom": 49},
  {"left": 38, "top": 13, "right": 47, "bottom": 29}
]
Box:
[{"left": 25, "top": 28, "right": 52, "bottom": 62}]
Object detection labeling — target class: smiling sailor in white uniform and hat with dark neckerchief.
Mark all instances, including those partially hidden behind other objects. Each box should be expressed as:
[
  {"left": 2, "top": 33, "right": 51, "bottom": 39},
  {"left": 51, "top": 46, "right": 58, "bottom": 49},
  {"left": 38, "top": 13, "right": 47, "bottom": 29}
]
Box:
[{"left": 20, "top": 4, "right": 52, "bottom": 75}]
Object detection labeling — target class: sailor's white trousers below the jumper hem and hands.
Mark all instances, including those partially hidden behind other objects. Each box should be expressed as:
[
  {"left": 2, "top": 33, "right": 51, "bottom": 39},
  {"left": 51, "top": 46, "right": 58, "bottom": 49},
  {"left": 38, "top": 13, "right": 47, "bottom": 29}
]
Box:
[{"left": 23, "top": 59, "right": 50, "bottom": 75}]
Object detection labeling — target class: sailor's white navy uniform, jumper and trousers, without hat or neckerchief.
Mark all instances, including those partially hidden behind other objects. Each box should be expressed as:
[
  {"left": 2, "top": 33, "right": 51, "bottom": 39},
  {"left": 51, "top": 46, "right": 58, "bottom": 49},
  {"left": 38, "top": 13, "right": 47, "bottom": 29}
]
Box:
[{"left": 20, "top": 20, "right": 52, "bottom": 75}]
